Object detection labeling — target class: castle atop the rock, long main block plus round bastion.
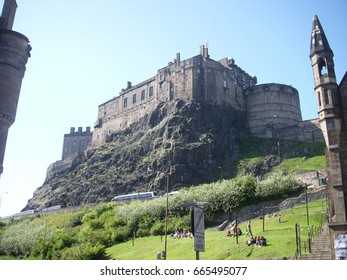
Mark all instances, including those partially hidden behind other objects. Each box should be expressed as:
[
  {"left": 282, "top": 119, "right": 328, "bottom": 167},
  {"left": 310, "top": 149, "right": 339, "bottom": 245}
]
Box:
[{"left": 91, "top": 45, "right": 312, "bottom": 147}]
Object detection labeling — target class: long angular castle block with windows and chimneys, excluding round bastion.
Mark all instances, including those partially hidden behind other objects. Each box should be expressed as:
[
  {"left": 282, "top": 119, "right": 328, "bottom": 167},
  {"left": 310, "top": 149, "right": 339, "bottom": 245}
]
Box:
[{"left": 91, "top": 48, "right": 257, "bottom": 147}]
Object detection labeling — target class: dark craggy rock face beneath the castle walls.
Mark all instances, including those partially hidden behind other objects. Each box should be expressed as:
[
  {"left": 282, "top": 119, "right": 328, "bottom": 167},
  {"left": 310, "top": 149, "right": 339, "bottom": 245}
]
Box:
[{"left": 24, "top": 100, "right": 249, "bottom": 209}]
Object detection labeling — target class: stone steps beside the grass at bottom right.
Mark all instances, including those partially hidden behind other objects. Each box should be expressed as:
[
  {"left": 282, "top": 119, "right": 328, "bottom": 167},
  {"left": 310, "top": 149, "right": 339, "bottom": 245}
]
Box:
[{"left": 300, "top": 225, "right": 331, "bottom": 260}]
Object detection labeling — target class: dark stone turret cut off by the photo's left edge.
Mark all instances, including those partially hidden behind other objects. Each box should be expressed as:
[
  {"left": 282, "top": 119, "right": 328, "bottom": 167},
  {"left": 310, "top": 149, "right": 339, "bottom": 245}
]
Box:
[{"left": 0, "top": 0, "right": 31, "bottom": 175}]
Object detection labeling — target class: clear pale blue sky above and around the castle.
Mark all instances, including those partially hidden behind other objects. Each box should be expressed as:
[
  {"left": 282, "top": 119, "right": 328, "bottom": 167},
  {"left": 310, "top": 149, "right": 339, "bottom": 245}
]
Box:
[{"left": 0, "top": 0, "right": 347, "bottom": 216}]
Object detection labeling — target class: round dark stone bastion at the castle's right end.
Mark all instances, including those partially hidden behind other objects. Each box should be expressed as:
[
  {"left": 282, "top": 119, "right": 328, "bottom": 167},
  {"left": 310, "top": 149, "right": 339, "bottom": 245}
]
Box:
[{"left": 244, "top": 83, "right": 302, "bottom": 138}]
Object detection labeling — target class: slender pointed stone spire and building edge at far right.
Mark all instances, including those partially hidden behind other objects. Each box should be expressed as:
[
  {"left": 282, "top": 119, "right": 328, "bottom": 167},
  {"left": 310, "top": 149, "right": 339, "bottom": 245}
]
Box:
[{"left": 310, "top": 16, "right": 347, "bottom": 259}]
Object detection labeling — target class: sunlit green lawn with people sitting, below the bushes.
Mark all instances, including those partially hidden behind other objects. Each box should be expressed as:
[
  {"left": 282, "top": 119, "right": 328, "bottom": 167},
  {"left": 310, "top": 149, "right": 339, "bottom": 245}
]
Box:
[{"left": 107, "top": 200, "right": 326, "bottom": 260}]
